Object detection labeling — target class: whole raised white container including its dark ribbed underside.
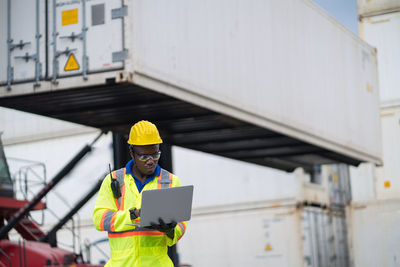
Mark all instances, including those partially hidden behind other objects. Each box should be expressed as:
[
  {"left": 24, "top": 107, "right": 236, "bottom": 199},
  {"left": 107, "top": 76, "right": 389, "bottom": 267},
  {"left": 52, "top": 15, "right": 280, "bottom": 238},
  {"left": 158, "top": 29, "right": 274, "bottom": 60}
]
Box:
[{"left": 0, "top": 0, "right": 382, "bottom": 171}]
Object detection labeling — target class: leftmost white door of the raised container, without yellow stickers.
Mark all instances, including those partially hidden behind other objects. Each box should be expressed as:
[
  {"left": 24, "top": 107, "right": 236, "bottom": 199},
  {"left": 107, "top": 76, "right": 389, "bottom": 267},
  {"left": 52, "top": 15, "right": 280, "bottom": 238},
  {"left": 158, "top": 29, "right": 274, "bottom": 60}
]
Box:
[{"left": 0, "top": 0, "right": 46, "bottom": 88}]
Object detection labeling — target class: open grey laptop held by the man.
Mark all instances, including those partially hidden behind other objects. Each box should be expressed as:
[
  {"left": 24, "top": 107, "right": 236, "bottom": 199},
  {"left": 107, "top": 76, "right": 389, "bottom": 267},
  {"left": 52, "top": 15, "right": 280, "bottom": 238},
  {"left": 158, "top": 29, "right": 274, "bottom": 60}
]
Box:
[{"left": 128, "top": 185, "right": 193, "bottom": 227}]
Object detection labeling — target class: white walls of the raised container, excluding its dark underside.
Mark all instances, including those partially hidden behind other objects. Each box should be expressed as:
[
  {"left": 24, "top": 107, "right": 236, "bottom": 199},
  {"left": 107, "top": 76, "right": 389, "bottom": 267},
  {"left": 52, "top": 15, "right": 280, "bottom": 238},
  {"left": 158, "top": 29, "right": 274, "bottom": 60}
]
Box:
[{"left": 0, "top": 0, "right": 381, "bottom": 164}]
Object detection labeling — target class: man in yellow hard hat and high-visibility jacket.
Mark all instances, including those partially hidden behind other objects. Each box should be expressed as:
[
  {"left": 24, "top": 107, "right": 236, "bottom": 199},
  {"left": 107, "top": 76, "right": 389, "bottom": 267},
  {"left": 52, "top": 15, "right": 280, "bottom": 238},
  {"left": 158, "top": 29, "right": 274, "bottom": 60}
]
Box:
[{"left": 93, "top": 121, "right": 186, "bottom": 266}]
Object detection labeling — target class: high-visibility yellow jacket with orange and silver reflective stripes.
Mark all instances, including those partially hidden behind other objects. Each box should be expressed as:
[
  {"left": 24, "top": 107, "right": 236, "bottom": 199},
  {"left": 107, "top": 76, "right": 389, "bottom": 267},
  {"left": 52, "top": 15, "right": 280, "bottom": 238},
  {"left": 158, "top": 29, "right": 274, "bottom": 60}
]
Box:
[{"left": 93, "top": 168, "right": 186, "bottom": 267}]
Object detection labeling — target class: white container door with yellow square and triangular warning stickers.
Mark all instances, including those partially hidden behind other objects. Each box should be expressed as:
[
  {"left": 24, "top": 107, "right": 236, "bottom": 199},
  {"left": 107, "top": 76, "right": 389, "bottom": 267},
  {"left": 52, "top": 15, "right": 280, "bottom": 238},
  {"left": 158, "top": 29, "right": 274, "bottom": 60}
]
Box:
[{"left": 48, "top": 0, "right": 127, "bottom": 82}]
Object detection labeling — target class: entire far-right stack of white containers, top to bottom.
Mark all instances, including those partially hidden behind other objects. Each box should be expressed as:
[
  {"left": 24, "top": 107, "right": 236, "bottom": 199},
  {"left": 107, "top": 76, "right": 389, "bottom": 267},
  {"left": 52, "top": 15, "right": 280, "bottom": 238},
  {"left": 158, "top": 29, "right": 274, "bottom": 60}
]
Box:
[{"left": 348, "top": 0, "right": 400, "bottom": 266}]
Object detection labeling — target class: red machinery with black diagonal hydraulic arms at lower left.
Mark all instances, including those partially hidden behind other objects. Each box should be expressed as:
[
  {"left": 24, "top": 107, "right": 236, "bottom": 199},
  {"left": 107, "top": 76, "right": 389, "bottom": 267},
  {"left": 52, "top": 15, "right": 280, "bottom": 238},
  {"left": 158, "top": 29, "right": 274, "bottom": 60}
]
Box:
[{"left": 0, "top": 135, "right": 103, "bottom": 267}]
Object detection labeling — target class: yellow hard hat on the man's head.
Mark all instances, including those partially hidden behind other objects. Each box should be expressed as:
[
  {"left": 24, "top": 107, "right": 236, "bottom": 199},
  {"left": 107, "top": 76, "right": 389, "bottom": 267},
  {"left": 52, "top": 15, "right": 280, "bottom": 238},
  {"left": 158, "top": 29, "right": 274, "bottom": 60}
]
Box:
[{"left": 128, "top": 121, "right": 162, "bottom": 146}]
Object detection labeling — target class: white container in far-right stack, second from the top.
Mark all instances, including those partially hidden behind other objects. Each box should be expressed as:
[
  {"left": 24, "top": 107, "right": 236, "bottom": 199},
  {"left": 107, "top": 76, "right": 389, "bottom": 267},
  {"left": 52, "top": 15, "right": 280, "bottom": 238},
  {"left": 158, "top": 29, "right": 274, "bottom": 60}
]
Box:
[{"left": 359, "top": 11, "right": 400, "bottom": 107}]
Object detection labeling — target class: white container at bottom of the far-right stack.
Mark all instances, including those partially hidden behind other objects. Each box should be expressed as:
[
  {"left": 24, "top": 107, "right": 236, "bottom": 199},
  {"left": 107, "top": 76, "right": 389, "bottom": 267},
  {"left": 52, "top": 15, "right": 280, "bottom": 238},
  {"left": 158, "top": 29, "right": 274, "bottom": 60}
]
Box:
[{"left": 346, "top": 199, "right": 400, "bottom": 267}]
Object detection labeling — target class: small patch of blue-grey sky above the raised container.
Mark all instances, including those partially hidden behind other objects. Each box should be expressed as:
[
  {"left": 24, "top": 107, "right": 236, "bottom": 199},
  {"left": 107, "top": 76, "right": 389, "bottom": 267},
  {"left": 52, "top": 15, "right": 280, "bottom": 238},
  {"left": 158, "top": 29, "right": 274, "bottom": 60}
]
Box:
[{"left": 314, "top": 0, "right": 358, "bottom": 35}]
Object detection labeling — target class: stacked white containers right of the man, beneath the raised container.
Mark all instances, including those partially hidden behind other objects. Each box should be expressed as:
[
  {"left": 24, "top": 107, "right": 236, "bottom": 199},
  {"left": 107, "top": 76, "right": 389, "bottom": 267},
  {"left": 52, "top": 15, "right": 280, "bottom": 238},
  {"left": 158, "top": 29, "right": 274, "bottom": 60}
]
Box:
[{"left": 174, "top": 148, "right": 351, "bottom": 267}]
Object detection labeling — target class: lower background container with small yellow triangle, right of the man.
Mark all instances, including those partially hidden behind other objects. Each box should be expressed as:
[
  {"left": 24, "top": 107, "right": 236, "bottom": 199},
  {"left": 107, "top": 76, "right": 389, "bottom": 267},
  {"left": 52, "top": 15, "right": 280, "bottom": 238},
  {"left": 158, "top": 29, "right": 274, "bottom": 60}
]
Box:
[{"left": 178, "top": 200, "right": 350, "bottom": 267}]
